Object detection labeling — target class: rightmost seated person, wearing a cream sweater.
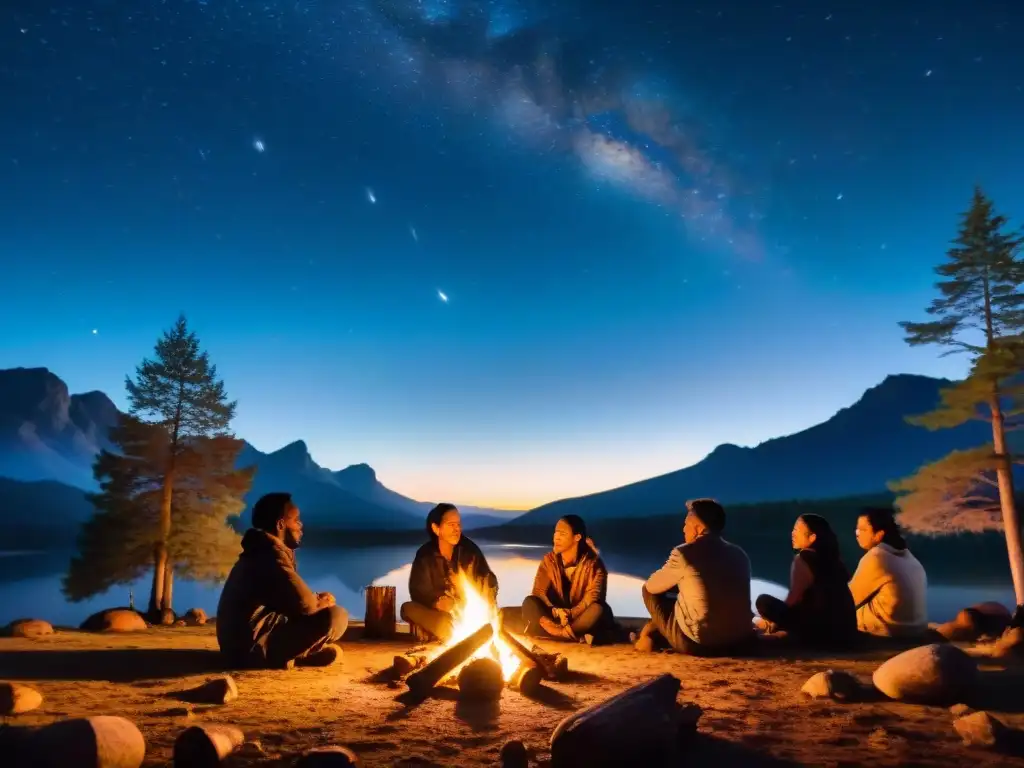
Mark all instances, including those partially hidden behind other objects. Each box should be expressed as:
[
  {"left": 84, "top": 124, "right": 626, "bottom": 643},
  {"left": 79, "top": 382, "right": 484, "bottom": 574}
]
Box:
[{"left": 850, "top": 508, "right": 928, "bottom": 638}]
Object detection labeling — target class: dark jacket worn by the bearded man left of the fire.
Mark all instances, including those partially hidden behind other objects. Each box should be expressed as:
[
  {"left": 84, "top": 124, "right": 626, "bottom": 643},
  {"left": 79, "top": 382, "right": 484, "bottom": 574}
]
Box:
[{"left": 217, "top": 528, "right": 318, "bottom": 663}]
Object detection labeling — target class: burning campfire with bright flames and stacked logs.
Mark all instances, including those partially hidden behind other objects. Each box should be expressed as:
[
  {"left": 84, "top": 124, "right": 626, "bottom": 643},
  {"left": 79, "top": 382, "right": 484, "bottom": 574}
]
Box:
[{"left": 394, "top": 573, "right": 567, "bottom": 699}]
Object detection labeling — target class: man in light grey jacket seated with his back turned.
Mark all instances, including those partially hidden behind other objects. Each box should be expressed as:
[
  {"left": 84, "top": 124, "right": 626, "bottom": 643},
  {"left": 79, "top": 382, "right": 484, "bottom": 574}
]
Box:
[{"left": 635, "top": 499, "right": 755, "bottom": 655}]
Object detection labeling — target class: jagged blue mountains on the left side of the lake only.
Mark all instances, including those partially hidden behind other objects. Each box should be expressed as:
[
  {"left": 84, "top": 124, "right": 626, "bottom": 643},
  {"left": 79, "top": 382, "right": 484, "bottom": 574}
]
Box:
[{"left": 0, "top": 368, "right": 518, "bottom": 530}]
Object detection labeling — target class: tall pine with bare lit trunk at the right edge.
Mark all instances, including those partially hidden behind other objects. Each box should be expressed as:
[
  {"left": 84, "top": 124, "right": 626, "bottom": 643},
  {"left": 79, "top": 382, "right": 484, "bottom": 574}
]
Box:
[{"left": 896, "top": 188, "right": 1024, "bottom": 614}]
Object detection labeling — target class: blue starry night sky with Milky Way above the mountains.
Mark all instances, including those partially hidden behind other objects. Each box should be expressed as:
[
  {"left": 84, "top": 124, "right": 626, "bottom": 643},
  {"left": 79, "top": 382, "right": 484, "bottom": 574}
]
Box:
[{"left": 0, "top": 0, "right": 1024, "bottom": 509}]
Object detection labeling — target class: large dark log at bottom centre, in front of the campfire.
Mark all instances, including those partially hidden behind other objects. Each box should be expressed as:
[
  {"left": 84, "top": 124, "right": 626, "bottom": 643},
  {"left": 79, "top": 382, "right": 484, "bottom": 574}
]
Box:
[{"left": 551, "top": 675, "right": 682, "bottom": 768}]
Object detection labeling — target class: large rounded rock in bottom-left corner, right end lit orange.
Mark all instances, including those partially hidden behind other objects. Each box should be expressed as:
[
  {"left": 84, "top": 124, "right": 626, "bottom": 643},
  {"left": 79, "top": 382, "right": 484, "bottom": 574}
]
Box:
[{"left": 33, "top": 715, "right": 145, "bottom": 768}]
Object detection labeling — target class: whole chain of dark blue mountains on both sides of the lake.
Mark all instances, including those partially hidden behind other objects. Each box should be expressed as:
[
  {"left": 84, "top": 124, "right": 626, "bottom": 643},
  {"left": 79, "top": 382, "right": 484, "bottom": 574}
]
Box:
[{"left": 0, "top": 369, "right": 1007, "bottom": 531}]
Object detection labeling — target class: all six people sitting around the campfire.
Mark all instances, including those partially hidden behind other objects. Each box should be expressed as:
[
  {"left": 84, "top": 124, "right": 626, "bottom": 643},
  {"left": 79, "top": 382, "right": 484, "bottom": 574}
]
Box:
[{"left": 216, "top": 493, "right": 928, "bottom": 669}]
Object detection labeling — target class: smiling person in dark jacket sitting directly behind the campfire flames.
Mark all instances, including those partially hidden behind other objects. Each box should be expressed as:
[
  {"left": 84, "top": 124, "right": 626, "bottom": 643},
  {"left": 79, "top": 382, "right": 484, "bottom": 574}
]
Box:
[{"left": 399, "top": 503, "right": 498, "bottom": 642}]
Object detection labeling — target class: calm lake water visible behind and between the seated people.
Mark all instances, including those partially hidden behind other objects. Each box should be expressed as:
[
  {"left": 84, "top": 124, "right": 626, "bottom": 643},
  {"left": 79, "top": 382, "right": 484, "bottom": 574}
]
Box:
[{"left": 0, "top": 542, "right": 1014, "bottom": 626}]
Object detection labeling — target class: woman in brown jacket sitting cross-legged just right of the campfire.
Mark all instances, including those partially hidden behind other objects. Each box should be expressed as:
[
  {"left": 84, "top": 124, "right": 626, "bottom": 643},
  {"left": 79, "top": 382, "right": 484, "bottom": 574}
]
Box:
[{"left": 522, "top": 515, "right": 614, "bottom": 640}]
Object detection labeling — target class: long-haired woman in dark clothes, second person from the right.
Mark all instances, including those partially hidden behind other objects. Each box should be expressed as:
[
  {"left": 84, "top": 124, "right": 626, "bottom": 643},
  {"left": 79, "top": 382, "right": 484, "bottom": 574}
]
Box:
[{"left": 755, "top": 513, "right": 857, "bottom": 648}]
